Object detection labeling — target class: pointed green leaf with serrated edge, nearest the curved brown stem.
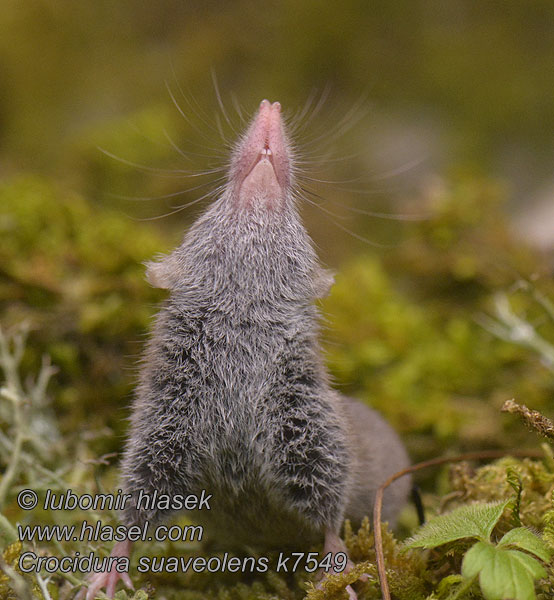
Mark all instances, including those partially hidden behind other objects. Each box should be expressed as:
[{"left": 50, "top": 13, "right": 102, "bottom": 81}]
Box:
[{"left": 406, "top": 500, "right": 510, "bottom": 548}]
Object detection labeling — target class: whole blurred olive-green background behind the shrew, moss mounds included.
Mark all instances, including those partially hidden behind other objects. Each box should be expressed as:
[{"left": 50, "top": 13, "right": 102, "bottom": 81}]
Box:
[{"left": 0, "top": 0, "right": 554, "bottom": 459}]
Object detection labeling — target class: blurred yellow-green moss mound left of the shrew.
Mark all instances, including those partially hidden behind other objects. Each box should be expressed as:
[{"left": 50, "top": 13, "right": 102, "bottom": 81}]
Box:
[{"left": 0, "top": 176, "right": 166, "bottom": 440}]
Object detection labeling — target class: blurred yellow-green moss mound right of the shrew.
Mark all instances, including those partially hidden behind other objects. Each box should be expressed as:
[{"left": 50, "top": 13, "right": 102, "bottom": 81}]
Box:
[{"left": 323, "top": 180, "right": 554, "bottom": 458}]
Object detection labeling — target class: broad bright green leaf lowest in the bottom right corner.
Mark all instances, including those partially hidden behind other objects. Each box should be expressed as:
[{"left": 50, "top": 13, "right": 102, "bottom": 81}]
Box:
[{"left": 462, "top": 542, "right": 546, "bottom": 600}]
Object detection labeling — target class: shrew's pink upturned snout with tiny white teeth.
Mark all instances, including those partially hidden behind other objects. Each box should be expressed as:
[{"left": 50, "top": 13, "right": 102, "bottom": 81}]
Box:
[{"left": 233, "top": 100, "right": 290, "bottom": 206}]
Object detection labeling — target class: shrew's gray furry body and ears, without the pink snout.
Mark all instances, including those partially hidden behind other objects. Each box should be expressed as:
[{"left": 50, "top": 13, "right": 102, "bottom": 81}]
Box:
[{"left": 117, "top": 116, "right": 409, "bottom": 548}]
